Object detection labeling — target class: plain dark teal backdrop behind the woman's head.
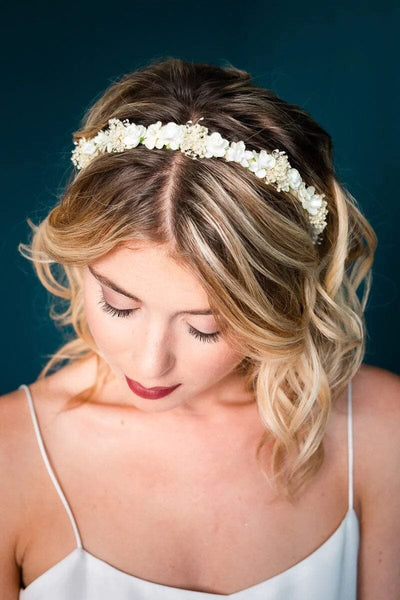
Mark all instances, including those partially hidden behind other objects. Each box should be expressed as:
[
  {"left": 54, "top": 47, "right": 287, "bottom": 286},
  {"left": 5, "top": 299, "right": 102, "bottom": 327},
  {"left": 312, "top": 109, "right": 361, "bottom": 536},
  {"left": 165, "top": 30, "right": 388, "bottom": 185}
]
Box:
[{"left": 0, "top": 0, "right": 400, "bottom": 393}]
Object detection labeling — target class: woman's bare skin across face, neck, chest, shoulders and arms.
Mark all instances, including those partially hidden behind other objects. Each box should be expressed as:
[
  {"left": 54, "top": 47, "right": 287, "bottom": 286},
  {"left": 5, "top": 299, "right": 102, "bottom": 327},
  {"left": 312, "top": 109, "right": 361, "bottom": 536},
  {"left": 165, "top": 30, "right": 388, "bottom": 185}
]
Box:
[{"left": 0, "top": 241, "right": 400, "bottom": 600}]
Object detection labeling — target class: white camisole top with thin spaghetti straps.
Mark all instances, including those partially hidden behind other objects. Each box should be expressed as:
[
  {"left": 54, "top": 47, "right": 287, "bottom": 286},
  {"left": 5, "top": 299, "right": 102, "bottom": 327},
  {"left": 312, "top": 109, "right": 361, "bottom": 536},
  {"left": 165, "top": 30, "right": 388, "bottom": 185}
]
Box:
[{"left": 19, "top": 381, "right": 359, "bottom": 600}]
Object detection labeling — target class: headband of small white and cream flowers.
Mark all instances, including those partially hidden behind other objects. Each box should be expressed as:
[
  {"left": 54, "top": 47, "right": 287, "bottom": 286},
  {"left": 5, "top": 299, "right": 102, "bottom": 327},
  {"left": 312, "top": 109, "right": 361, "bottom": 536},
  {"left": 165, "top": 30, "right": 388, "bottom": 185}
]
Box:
[{"left": 71, "top": 117, "right": 328, "bottom": 244}]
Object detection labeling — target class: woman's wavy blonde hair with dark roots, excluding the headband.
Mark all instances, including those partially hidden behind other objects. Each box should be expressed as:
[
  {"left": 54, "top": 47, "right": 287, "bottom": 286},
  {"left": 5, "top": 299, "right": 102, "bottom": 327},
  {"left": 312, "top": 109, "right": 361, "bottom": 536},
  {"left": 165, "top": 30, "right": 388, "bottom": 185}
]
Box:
[{"left": 18, "top": 57, "right": 377, "bottom": 501}]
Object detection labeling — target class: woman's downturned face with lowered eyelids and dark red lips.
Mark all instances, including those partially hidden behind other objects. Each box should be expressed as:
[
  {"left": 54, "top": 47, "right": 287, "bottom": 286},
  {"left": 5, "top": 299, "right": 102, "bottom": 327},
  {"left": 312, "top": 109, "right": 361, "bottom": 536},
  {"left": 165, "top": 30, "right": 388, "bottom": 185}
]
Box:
[{"left": 83, "top": 242, "right": 247, "bottom": 412}]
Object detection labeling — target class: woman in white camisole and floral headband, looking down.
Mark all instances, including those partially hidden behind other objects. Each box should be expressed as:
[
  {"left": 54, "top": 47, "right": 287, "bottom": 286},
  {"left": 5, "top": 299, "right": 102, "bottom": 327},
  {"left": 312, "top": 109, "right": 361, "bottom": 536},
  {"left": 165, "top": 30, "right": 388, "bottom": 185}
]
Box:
[{"left": 0, "top": 58, "right": 400, "bottom": 600}]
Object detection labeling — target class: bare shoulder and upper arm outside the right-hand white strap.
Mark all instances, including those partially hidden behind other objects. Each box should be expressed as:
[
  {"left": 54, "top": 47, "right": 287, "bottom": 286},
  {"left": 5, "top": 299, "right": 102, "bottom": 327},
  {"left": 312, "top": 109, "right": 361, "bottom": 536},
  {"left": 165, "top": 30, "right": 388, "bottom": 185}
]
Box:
[{"left": 353, "top": 365, "right": 400, "bottom": 600}]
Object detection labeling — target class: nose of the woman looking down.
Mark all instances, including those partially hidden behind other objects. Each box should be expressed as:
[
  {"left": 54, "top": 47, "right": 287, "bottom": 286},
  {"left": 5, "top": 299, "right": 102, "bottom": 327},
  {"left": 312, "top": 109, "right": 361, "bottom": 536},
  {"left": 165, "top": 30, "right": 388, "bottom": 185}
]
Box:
[{"left": 134, "top": 320, "right": 175, "bottom": 380}]
